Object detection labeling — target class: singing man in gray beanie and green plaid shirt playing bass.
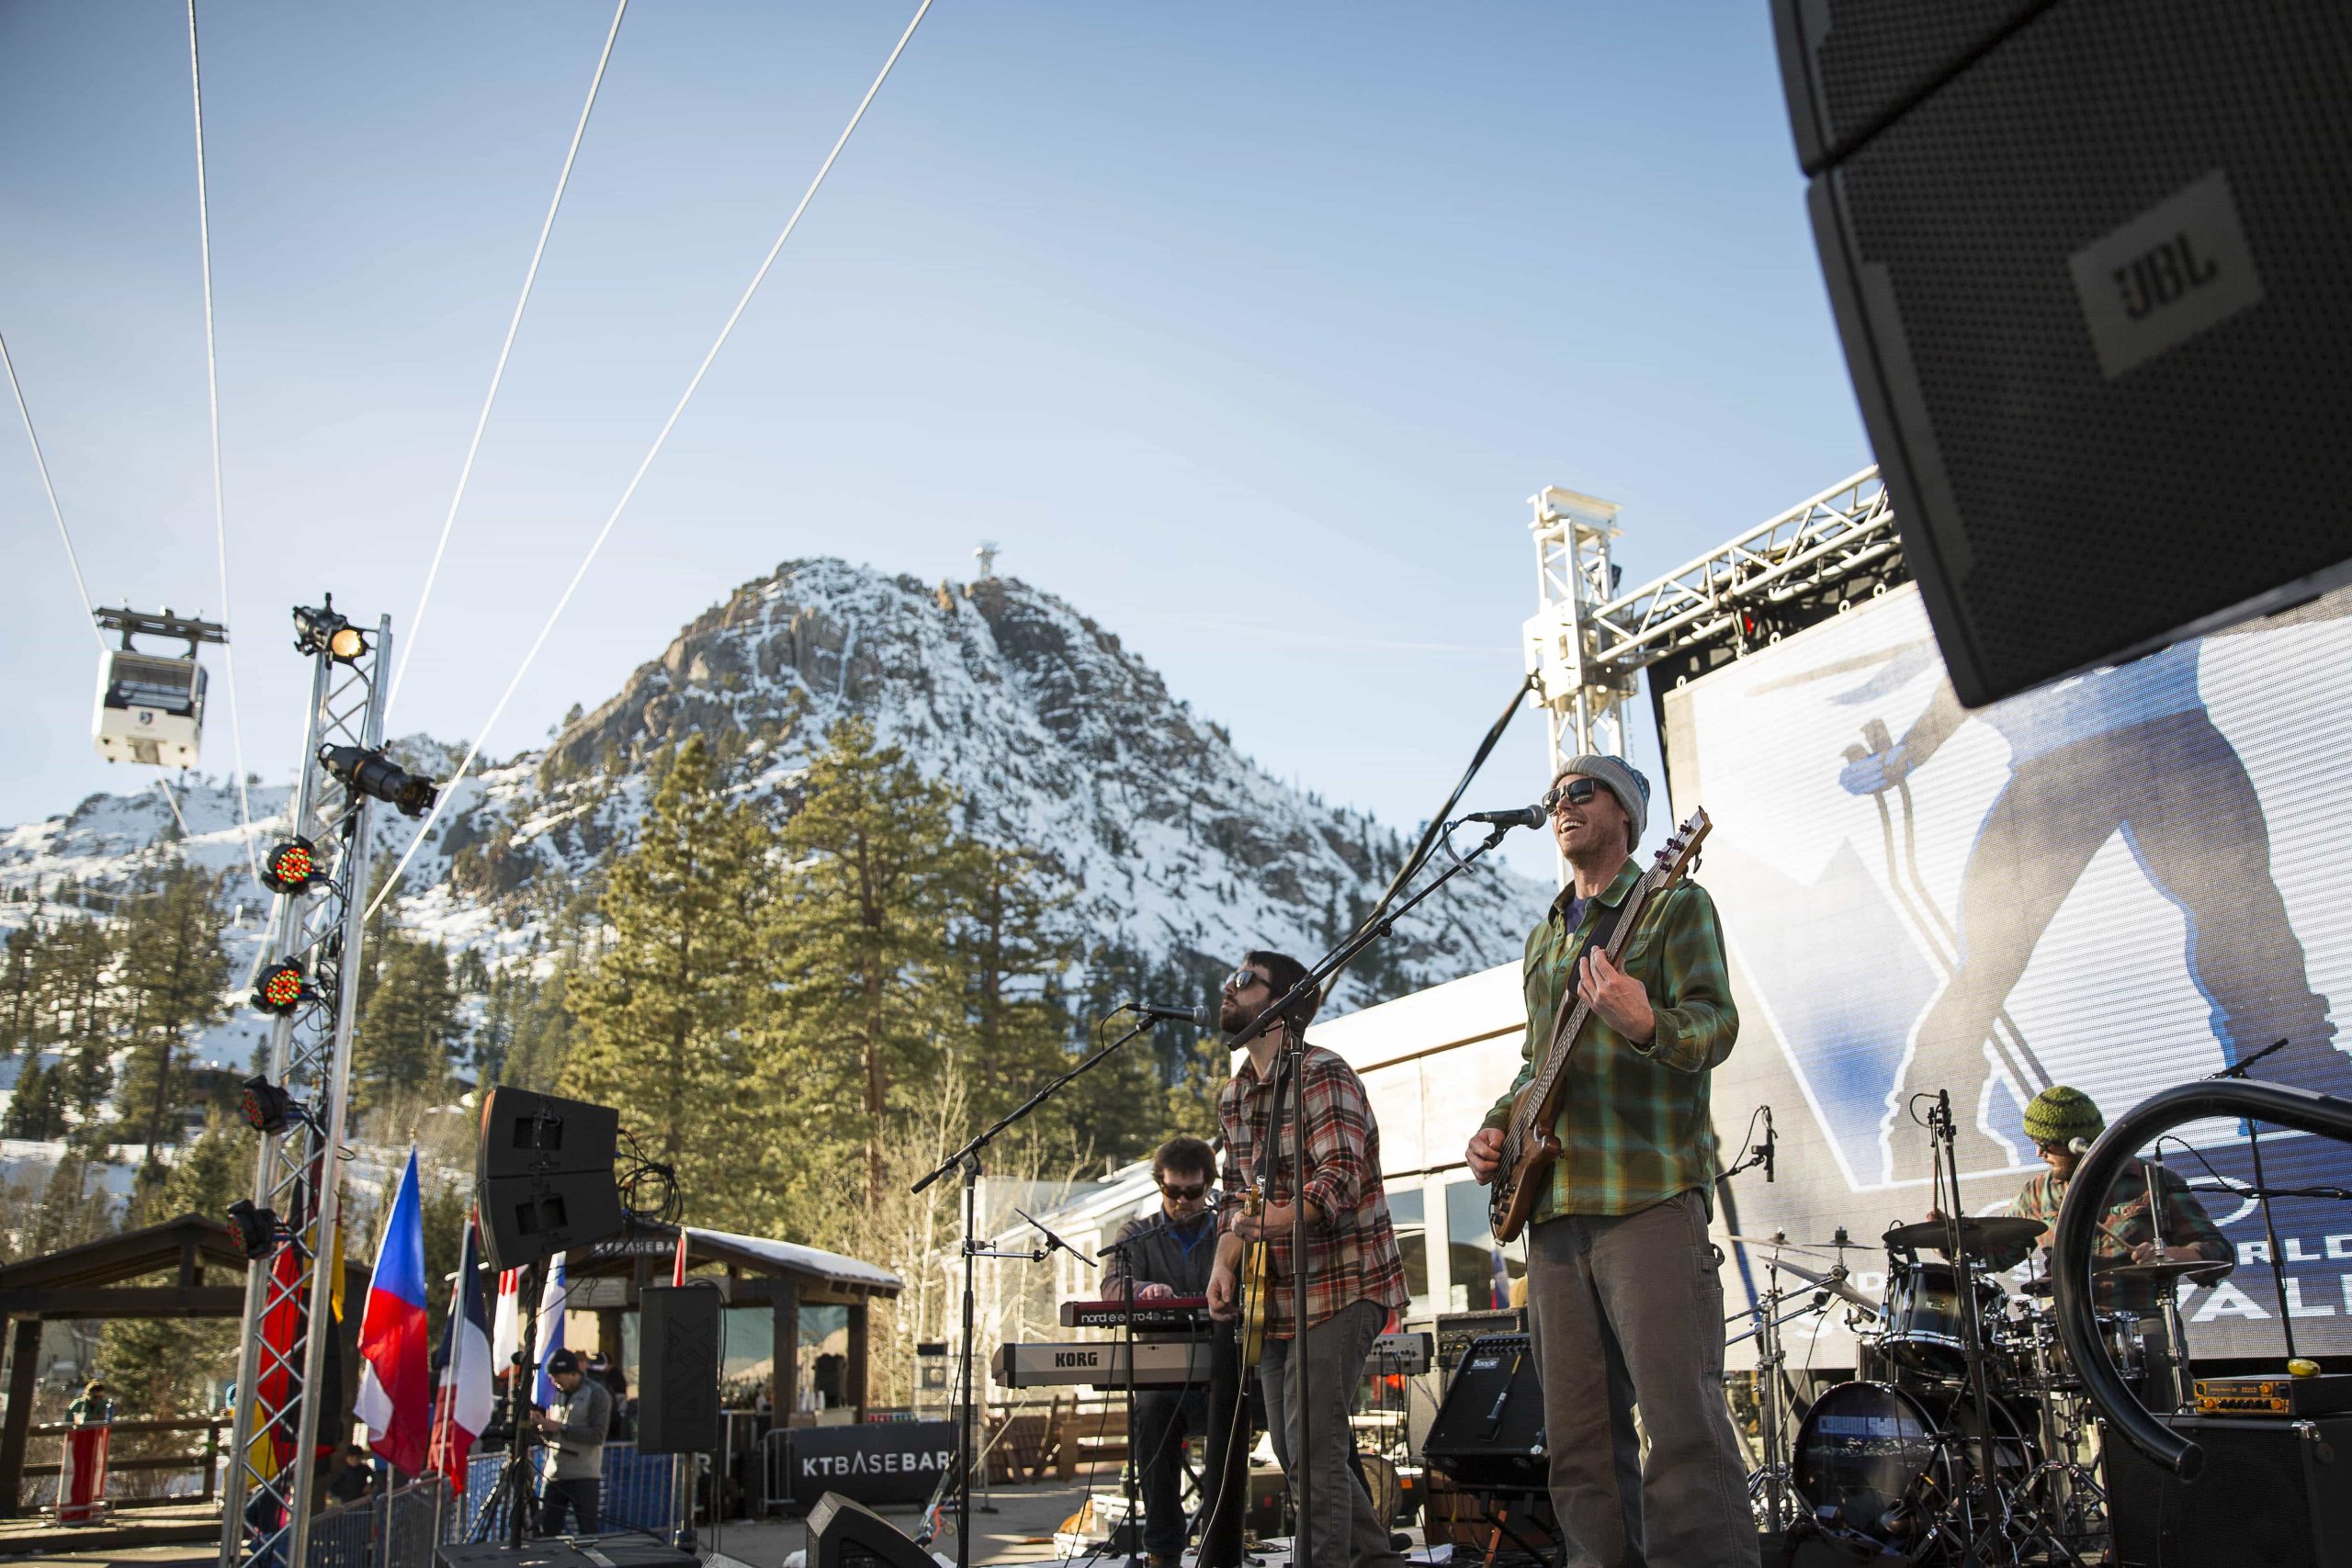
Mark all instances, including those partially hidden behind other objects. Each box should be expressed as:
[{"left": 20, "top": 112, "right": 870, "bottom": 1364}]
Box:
[{"left": 1465, "top": 755, "right": 1757, "bottom": 1568}]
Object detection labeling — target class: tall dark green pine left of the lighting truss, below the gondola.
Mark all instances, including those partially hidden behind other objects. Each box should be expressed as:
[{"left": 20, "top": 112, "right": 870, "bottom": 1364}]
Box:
[{"left": 118, "top": 863, "right": 228, "bottom": 1164}]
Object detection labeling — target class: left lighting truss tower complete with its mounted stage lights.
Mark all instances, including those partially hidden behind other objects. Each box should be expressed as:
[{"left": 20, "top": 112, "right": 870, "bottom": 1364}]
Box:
[{"left": 221, "top": 600, "right": 395, "bottom": 1568}]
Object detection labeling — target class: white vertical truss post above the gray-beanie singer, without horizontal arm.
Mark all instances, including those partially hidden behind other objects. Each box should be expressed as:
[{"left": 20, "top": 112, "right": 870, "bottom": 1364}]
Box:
[{"left": 1526, "top": 484, "right": 1642, "bottom": 773}]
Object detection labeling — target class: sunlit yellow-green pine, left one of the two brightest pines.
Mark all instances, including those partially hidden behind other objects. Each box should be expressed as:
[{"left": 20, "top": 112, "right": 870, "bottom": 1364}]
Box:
[{"left": 562, "top": 736, "right": 774, "bottom": 1220}]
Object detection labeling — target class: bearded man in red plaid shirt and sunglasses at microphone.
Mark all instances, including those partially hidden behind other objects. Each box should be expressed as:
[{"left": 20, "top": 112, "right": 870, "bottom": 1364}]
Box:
[{"left": 1209, "top": 952, "right": 1408, "bottom": 1568}]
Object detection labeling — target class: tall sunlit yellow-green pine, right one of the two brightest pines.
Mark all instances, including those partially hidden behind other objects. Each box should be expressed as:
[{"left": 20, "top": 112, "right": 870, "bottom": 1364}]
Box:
[{"left": 769, "top": 719, "right": 976, "bottom": 1206}]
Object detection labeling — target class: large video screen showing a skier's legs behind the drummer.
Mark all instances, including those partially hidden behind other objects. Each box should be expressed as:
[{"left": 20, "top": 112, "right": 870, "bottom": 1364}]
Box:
[{"left": 1663, "top": 588, "right": 2352, "bottom": 1366}]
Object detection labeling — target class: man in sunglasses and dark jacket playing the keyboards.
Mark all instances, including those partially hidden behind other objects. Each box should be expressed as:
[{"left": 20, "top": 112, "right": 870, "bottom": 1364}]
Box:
[{"left": 1103, "top": 1138, "right": 1216, "bottom": 1568}]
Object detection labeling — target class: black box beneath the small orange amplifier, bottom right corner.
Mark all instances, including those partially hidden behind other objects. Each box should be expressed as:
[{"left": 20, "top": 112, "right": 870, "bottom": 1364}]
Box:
[{"left": 2100, "top": 1416, "right": 2352, "bottom": 1568}]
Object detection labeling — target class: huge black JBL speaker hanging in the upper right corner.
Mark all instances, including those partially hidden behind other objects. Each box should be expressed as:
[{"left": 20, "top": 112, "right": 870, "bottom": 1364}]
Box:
[{"left": 1776, "top": 0, "right": 2352, "bottom": 705}]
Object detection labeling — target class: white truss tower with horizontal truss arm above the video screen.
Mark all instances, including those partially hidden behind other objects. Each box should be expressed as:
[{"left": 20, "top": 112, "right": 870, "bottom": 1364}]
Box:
[{"left": 1526, "top": 468, "right": 1903, "bottom": 769}]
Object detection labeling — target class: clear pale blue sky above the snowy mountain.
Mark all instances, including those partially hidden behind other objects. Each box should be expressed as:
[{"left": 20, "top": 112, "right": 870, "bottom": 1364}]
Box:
[{"left": 0, "top": 0, "right": 1870, "bottom": 872}]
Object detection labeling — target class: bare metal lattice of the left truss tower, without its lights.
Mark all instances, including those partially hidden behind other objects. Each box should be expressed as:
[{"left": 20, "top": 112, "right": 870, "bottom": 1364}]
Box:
[{"left": 221, "top": 609, "right": 393, "bottom": 1568}]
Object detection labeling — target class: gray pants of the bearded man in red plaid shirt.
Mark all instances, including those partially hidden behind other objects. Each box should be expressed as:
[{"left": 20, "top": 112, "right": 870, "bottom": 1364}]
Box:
[{"left": 1259, "top": 1303, "right": 1404, "bottom": 1568}]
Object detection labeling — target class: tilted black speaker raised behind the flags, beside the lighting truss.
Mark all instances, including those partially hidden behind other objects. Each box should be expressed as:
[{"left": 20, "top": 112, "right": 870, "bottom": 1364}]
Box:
[{"left": 473, "top": 1084, "right": 621, "bottom": 1269}]
